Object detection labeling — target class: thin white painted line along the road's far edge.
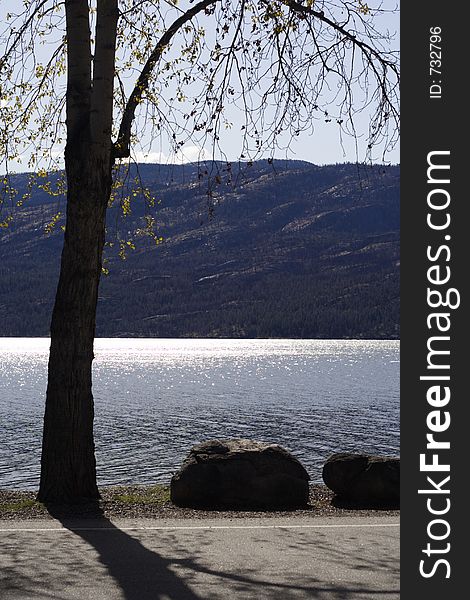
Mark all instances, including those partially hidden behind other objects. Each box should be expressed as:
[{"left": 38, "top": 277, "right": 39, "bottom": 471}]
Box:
[{"left": 0, "top": 523, "right": 400, "bottom": 533}]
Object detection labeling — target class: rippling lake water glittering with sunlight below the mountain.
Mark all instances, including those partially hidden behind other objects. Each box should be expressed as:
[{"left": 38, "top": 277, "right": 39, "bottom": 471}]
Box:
[{"left": 0, "top": 338, "right": 399, "bottom": 489}]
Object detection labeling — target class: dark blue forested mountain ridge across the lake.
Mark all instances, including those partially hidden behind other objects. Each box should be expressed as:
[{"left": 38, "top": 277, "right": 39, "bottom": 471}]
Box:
[{"left": 0, "top": 161, "right": 399, "bottom": 338}]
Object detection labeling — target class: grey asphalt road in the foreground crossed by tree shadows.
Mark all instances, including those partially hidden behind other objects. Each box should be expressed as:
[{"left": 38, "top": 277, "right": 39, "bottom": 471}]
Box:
[{"left": 0, "top": 517, "right": 400, "bottom": 600}]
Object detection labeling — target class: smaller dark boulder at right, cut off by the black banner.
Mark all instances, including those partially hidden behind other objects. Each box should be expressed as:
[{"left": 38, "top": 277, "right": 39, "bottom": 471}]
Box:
[{"left": 323, "top": 453, "right": 400, "bottom": 506}]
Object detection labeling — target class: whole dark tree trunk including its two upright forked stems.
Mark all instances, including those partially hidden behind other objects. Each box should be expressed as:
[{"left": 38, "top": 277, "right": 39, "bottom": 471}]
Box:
[{"left": 38, "top": 0, "right": 118, "bottom": 503}]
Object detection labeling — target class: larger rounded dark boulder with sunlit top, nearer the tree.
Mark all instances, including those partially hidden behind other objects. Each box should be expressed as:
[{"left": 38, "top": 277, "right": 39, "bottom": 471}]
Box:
[{"left": 171, "top": 439, "right": 310, "bottom": 510}]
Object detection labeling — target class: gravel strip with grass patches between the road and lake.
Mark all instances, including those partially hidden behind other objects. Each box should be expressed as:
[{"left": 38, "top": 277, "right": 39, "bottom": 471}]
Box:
[{"left": 0, "top": 484, "right": 400, "bottom": 520}]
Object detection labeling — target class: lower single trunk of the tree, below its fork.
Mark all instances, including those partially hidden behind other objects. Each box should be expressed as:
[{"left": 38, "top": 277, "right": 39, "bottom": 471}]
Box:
[{"left": 38, "top": 150, "right": 111, "bottom": 503}]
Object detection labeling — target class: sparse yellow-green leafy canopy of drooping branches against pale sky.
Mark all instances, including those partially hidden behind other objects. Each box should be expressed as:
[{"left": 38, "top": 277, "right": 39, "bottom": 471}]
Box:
[{"left": 0, "top": 0, "right": 398, "bottom": 178}]
